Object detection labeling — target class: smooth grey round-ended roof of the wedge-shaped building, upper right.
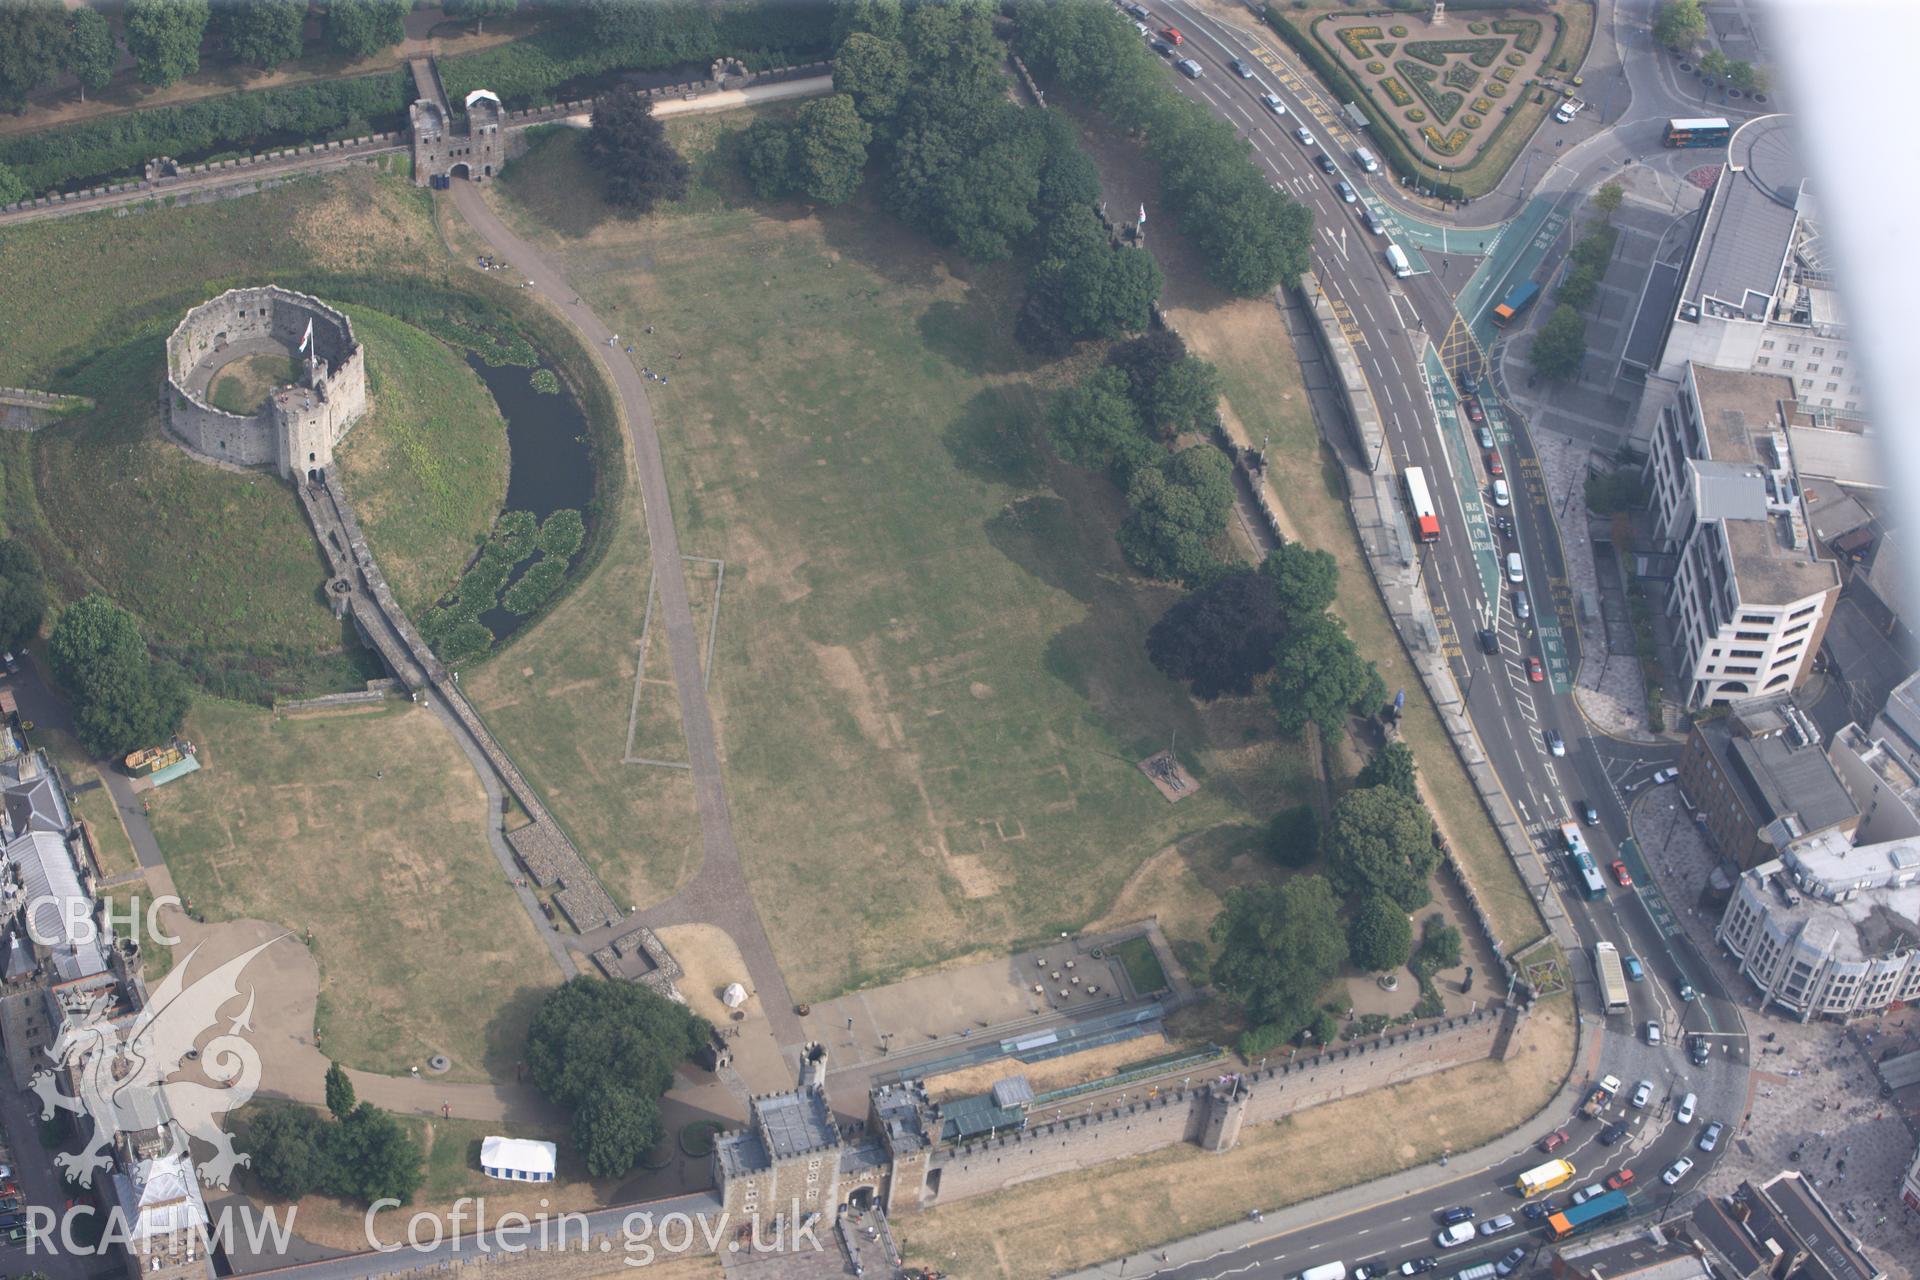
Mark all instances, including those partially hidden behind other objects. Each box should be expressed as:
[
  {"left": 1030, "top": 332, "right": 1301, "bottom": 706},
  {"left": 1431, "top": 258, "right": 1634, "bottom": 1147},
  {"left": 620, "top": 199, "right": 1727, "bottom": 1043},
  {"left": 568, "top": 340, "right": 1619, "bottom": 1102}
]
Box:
[{"left": 1682, "top": 119, "right": 1805, "bottom": 320}]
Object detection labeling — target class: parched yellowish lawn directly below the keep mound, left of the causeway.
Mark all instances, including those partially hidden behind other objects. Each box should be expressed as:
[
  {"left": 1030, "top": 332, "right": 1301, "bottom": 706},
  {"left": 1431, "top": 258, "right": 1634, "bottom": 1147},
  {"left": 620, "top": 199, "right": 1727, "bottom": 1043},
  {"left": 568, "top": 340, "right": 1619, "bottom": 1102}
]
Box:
[{"left": 148, "top": 699, "right": 561, "bottom": 1080}]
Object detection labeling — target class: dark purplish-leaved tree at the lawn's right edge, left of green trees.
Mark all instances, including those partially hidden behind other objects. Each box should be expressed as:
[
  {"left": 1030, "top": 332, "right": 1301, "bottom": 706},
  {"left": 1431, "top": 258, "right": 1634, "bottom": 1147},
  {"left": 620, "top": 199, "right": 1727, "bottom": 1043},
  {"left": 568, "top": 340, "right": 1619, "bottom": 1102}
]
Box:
[{"left": 1146, "top": 568, "right": 1286, "bottom": 702}]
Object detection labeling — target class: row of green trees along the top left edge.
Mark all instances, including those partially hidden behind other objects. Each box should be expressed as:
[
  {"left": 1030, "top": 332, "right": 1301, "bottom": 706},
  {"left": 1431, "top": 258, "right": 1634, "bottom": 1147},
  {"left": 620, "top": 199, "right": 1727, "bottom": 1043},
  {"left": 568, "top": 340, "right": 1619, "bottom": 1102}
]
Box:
[{"left": 0, "top": 0, "right": 418, "bottom": 111}]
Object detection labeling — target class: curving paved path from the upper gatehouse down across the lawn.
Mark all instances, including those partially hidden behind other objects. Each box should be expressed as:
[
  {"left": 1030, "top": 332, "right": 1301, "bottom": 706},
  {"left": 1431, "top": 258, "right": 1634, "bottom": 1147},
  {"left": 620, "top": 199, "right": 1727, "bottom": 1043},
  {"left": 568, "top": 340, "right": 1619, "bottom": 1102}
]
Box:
[{"left": 453, "top": 182, "right": 804, "bottom": 1046}]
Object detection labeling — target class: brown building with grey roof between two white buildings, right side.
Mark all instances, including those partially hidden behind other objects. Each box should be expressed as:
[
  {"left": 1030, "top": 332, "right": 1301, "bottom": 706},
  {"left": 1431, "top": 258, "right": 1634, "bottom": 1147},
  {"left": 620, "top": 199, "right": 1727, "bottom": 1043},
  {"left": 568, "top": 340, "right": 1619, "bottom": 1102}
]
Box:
[{"left": 1680, "top": 693, "right": 1860, "bottom": 867}]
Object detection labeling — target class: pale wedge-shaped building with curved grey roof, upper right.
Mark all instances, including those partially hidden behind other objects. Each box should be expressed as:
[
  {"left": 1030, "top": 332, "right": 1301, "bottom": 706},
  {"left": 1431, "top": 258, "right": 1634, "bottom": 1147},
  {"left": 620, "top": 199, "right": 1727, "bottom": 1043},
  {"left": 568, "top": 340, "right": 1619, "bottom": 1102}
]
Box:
[{"left": 1647, "top": 117, "right": 1866, "bottom": 420}]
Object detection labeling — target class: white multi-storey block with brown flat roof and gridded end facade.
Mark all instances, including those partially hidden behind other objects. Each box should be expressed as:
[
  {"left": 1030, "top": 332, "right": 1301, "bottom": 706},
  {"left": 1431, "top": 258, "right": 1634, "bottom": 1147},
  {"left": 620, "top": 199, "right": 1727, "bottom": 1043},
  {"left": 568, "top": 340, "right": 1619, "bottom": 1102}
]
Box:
[{"left": 1647, "top": 365, "right": 1839, "bottom": 706}]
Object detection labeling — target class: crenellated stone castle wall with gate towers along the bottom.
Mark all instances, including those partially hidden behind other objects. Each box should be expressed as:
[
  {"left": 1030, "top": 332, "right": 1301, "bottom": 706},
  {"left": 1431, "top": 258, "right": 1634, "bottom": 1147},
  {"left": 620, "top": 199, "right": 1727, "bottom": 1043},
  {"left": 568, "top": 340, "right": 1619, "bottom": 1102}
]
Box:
[{"left": 712, "top": 1007, "right": 1524, "bottom": 1224}]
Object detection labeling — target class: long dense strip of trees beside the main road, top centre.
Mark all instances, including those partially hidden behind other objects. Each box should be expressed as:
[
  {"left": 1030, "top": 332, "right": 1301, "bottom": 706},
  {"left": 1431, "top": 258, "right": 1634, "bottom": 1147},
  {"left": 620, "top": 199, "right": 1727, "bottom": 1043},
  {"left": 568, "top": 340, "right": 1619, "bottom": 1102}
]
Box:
[{"left": 1012, "top": 0, "right": 1313, "bottom": 297}]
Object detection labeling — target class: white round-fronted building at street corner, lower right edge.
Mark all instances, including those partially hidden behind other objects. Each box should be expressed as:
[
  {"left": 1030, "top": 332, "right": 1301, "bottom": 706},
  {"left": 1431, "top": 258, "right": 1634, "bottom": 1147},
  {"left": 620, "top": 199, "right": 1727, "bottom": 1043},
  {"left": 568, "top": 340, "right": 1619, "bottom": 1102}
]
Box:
[{"left": 1715, "top": 831, "right": 1920, "bottom": 1021}]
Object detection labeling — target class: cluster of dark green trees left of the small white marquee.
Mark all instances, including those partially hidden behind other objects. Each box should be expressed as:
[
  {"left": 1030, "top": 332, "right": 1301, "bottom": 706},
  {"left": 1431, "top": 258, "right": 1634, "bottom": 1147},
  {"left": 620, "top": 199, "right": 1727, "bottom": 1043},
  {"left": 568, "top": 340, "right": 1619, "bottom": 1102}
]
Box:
[{"left": 246, "top": 1063, "right": 426, "bottom": 1205}]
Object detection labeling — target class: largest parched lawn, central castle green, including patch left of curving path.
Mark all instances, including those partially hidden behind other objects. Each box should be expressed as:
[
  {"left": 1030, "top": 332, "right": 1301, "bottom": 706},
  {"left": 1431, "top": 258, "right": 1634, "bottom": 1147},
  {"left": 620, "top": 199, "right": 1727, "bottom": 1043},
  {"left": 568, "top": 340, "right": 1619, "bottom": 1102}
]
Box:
[{"left": 468, "top": 115, "right": 1306, "bottom": 1000}]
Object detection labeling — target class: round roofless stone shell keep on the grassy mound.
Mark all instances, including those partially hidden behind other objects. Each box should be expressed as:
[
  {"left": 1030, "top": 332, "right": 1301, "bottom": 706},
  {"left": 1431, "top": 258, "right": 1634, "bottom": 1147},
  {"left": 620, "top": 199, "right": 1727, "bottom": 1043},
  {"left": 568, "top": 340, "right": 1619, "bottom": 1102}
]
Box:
[{"left": 167, "top": 284, "right": 367, "bottom": 480}]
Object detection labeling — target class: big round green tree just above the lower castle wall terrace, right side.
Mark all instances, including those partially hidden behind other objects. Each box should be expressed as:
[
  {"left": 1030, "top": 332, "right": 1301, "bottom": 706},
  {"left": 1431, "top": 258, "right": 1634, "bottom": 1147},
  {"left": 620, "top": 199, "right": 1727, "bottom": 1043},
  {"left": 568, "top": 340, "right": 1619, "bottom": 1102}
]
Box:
[{"left": 1213, "top": 875, "right": 1346, "bottom": 1036}]
